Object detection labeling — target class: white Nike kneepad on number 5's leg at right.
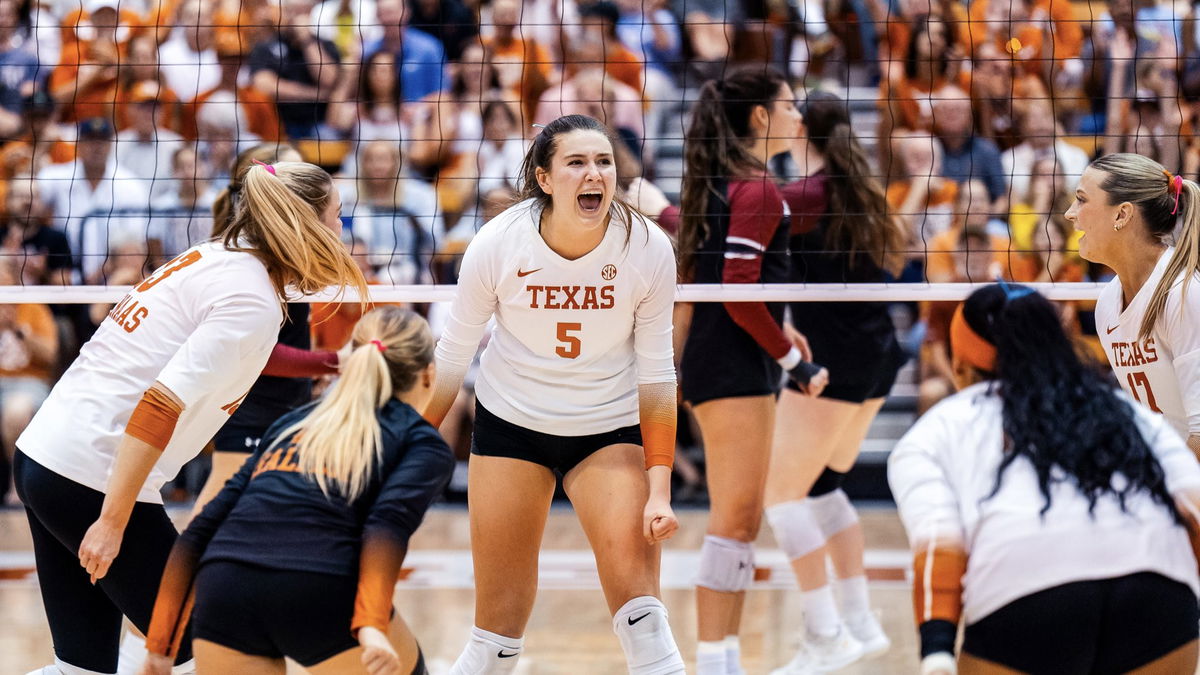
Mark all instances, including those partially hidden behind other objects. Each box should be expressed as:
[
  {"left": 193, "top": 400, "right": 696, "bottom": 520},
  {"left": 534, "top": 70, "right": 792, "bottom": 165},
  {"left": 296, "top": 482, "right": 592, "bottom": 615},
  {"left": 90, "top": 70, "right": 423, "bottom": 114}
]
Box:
[{"left": 612, "top": 596, "right": 684, "bottom": 675}]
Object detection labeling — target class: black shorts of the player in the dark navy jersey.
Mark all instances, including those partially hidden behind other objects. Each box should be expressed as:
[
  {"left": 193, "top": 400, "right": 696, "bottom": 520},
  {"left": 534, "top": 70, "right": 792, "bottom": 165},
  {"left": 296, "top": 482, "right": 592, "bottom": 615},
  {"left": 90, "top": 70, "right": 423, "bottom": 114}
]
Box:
[{"left": 192, "top": 560, "right": 359, "bottom": 668}]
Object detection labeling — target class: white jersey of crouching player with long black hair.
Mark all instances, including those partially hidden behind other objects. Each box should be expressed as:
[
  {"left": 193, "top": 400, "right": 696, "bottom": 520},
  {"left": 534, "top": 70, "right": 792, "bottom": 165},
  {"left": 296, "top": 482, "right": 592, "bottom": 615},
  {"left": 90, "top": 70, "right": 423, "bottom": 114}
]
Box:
[{"left": 888, "top": 382, "right": 1200, "bottom": 625}]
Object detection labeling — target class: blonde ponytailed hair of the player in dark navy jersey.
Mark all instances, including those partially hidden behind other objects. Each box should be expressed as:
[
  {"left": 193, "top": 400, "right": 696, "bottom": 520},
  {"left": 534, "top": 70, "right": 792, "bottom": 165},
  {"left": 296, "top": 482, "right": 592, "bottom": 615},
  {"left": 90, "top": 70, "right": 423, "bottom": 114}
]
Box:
[{"left": 265, "top": 306, "right": 433, "bottom": 501}]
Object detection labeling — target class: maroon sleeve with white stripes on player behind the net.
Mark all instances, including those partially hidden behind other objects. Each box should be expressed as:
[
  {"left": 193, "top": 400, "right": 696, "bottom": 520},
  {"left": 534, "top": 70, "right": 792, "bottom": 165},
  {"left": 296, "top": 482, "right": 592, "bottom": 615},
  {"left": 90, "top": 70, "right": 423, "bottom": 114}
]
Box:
[{"left": 721, "top": 178, "right": 792, "bottom": 359}]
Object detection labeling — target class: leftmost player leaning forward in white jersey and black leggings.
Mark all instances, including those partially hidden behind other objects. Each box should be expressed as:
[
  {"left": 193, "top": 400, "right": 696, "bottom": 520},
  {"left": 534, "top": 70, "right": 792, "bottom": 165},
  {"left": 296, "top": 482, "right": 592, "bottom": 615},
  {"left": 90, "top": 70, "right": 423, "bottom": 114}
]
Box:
[{"left": 14, "top": 158, "right": 366, "bottom": 675}]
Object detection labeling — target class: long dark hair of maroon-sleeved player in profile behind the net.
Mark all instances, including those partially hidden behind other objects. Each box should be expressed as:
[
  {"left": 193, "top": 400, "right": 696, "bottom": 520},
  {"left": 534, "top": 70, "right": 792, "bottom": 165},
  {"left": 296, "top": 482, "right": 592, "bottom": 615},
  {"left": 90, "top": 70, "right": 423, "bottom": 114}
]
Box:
[{"left": 679, "top": 66, "right": 786, "bottom": 281}]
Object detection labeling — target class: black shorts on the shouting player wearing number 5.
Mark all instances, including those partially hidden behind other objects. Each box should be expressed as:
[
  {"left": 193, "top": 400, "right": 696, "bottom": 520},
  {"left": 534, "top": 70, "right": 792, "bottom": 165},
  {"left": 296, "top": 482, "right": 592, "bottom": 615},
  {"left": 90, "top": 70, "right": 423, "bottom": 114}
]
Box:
[{"left": 470, "top": 399, "right": 642, "bottom": 476}]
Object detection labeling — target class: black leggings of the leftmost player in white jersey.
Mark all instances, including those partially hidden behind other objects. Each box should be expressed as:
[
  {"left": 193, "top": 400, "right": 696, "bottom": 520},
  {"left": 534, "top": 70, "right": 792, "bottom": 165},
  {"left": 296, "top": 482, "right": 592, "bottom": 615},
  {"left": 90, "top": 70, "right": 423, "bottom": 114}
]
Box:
[{"left": 13, "top": 450, "right": 192, "bottom": 673}]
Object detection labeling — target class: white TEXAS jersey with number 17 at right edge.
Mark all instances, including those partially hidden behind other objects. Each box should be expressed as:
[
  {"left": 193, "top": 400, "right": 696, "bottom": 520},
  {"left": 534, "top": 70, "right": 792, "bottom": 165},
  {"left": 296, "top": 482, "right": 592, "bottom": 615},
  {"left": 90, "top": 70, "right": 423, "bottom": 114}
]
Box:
[{"left": 1096, "top": 249, "right": 1200, "bottom": 437}]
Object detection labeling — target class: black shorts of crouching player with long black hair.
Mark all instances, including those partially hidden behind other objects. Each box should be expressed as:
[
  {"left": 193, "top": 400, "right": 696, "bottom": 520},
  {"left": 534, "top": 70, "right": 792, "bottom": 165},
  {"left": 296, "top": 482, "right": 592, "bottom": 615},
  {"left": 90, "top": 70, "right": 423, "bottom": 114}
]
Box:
[{"left": 962, "top": 572, "right": 1200, "bottom": 675}]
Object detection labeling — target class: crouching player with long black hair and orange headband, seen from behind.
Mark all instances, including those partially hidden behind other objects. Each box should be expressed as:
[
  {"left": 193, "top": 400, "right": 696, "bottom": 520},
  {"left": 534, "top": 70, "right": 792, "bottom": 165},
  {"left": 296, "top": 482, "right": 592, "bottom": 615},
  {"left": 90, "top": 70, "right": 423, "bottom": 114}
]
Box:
[{"left": 888, "top": 285, "right": 1200, "bottom": 675}]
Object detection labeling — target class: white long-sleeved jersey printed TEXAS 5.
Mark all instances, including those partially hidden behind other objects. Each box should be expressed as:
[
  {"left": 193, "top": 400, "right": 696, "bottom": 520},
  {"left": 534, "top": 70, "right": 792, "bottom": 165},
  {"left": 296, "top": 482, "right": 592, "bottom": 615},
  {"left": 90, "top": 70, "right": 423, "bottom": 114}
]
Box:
[{"left": 437, "top": 201, "right": 676, "bottom": 436}]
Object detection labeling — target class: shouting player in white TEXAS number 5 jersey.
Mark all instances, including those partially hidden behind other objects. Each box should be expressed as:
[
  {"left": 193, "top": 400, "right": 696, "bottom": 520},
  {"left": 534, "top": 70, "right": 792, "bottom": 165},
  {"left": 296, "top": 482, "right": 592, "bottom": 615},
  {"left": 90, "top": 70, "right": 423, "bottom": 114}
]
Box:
[{"left": 426, "top": 115, "right": 684, "bottom": 675}]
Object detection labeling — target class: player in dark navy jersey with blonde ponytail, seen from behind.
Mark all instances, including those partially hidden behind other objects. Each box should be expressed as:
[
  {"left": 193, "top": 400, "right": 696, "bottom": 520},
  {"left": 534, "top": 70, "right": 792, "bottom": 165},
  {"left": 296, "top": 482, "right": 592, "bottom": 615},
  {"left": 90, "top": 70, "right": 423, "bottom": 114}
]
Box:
[{"left": 143, "top": 306, "right": 455, "bottom": 675}]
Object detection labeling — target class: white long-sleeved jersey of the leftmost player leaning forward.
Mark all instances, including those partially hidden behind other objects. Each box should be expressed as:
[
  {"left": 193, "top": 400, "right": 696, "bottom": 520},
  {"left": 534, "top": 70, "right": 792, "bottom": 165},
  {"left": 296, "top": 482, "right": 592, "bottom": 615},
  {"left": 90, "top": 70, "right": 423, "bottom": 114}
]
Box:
[{"left": 17, "top": 243, "right": 283, "bottom": 503}]
